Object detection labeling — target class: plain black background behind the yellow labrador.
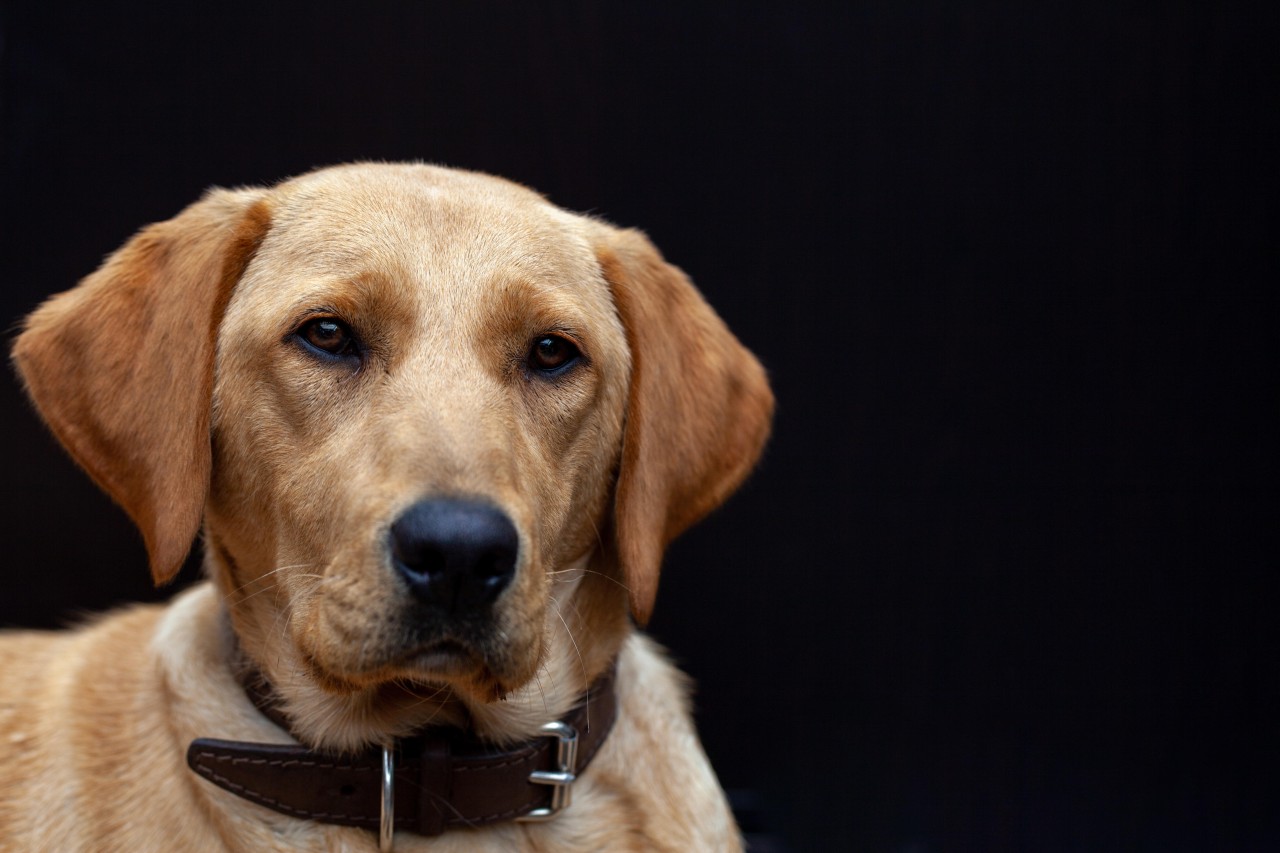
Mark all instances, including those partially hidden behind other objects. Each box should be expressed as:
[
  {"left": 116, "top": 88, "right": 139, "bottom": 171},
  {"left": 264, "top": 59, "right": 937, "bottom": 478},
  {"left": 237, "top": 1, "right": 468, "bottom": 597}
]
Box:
[{"left": 0, "top": 0, "right": 1280, "bottom": 853}]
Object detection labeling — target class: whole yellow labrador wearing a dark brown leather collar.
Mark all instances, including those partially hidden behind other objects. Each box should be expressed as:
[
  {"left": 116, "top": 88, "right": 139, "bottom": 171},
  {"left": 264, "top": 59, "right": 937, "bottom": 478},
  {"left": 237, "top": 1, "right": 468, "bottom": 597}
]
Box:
[{"left": 0, "top": 164, "right": 773, "bottom": 852}]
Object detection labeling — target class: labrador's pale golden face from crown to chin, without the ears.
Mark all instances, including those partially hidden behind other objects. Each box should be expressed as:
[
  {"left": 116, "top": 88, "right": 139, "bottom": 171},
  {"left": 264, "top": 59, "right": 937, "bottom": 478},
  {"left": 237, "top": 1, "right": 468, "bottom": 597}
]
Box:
[{"left": 207, "top": 169, "right": 631, "bottom": 695}]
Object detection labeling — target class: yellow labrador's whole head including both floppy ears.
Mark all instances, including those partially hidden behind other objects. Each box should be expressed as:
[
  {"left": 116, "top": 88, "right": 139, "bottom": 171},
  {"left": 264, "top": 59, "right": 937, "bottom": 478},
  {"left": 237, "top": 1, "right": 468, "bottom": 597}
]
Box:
[{"left": 14, "top": 165, "right": 773, "bottom": 745}]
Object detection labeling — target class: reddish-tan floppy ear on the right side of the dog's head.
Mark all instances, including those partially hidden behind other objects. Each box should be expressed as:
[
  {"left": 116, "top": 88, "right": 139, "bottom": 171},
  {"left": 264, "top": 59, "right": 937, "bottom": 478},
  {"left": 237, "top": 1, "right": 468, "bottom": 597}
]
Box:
[{"left": 596, "top": 228, "right": 773, "bottom": 625}]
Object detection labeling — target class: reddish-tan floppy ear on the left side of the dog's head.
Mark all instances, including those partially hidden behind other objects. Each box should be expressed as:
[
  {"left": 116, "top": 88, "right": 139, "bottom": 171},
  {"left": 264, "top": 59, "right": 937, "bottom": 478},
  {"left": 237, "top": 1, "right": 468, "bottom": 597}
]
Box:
[{"left": 13, "top": 190, "right": 270, "bottom": 584}]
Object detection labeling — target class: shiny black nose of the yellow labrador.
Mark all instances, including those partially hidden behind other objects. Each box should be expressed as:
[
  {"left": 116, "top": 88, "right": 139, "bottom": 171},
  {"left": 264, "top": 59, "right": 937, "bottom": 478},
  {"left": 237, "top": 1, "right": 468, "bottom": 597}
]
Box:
[{"left": 390, "top": 500, "right": 520, "bottom": 613}]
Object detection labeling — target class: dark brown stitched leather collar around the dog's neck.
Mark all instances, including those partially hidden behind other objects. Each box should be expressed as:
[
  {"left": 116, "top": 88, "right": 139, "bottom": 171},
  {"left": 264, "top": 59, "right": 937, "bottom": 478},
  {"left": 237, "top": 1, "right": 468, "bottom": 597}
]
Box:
[{"left": 187, "top": 667, "right": 617, "bottom": 838}]
